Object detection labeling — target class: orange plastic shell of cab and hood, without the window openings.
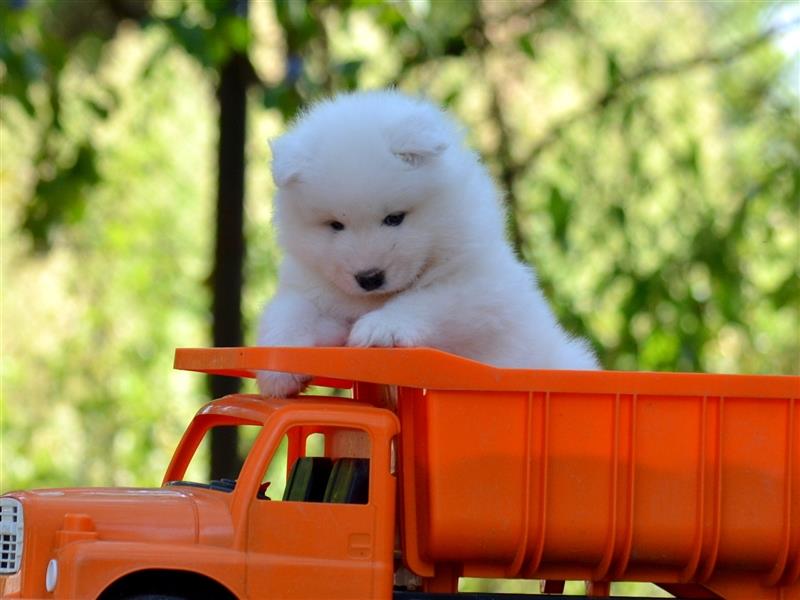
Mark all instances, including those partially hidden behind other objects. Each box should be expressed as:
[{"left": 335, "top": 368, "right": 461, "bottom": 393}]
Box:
[{"left": 0, "top": 395, "right": 399, "bottom": 600}]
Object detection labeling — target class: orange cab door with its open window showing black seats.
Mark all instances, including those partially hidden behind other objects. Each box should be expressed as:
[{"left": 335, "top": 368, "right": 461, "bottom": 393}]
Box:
[{"left": 247, "top": 426, "right": 376, "bottom": 600}]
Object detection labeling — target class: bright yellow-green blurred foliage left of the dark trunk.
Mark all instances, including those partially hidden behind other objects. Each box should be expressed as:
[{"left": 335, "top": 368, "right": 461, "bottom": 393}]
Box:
[{"left": 0, "top": 18, "right": 213, "bottom": 490}]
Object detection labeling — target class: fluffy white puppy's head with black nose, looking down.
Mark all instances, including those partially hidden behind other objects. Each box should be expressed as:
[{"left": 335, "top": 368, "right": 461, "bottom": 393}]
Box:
[{"left": 271, "top": 92, "right": 464, "bottom": 295}]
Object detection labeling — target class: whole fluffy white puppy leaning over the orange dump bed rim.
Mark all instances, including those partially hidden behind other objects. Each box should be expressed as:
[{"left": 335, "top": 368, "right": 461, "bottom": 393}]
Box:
[{"left": 258, "top": 91, "right": 598, "bottom": 397}]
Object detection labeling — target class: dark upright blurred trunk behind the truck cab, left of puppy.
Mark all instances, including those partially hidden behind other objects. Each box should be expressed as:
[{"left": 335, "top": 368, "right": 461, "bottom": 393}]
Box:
[{"left": 209, "top": 0, "right": 247, "bottom": 479}]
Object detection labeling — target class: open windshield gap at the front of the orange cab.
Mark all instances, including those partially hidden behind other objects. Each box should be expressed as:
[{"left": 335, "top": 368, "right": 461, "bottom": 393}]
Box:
[{"left": 167, "top": 425, "right": 262, "bottom": 492}]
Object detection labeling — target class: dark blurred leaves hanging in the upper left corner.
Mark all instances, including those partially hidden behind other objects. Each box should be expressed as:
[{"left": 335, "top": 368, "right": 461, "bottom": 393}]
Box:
[{"left": 0, "top": 0, "right": 252, "bottom": 251}]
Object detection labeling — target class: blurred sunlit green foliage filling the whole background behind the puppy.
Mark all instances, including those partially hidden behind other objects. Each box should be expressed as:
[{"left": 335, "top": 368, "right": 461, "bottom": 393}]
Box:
[{"left": 0, "top": 0, "right": 800, "bottom": 589}]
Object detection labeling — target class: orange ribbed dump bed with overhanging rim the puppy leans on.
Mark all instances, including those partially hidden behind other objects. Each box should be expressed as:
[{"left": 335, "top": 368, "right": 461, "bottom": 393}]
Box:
[{"left": 176, "top": 348, "right": 800, "bottom": 598}]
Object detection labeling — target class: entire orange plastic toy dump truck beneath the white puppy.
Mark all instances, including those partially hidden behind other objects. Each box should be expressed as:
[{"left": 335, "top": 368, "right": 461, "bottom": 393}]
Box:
[{"left": 0, "top": 348, "right": 800, "bottom": 600}]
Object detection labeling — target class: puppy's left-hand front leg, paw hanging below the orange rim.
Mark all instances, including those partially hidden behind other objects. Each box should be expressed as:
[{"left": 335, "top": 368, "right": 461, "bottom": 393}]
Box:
[{"left": 256, "top": 291, "right": 348, "bottom": 398}]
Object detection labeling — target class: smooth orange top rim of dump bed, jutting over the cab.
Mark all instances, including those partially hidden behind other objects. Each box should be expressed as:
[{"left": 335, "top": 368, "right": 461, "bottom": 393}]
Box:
[{"left": 174, "top": 347, "right": 800, "bottom": 398}]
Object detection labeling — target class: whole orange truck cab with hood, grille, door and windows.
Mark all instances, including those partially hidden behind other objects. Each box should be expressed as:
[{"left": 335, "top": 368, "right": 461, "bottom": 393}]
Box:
[{"left": 0, "top": 395, "right": 399, "bottom": 599}]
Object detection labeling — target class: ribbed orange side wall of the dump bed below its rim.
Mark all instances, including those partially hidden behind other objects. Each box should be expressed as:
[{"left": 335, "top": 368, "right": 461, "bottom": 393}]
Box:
[{"left": 399, "top": 390, "right": 800, "bottom": 597}]
